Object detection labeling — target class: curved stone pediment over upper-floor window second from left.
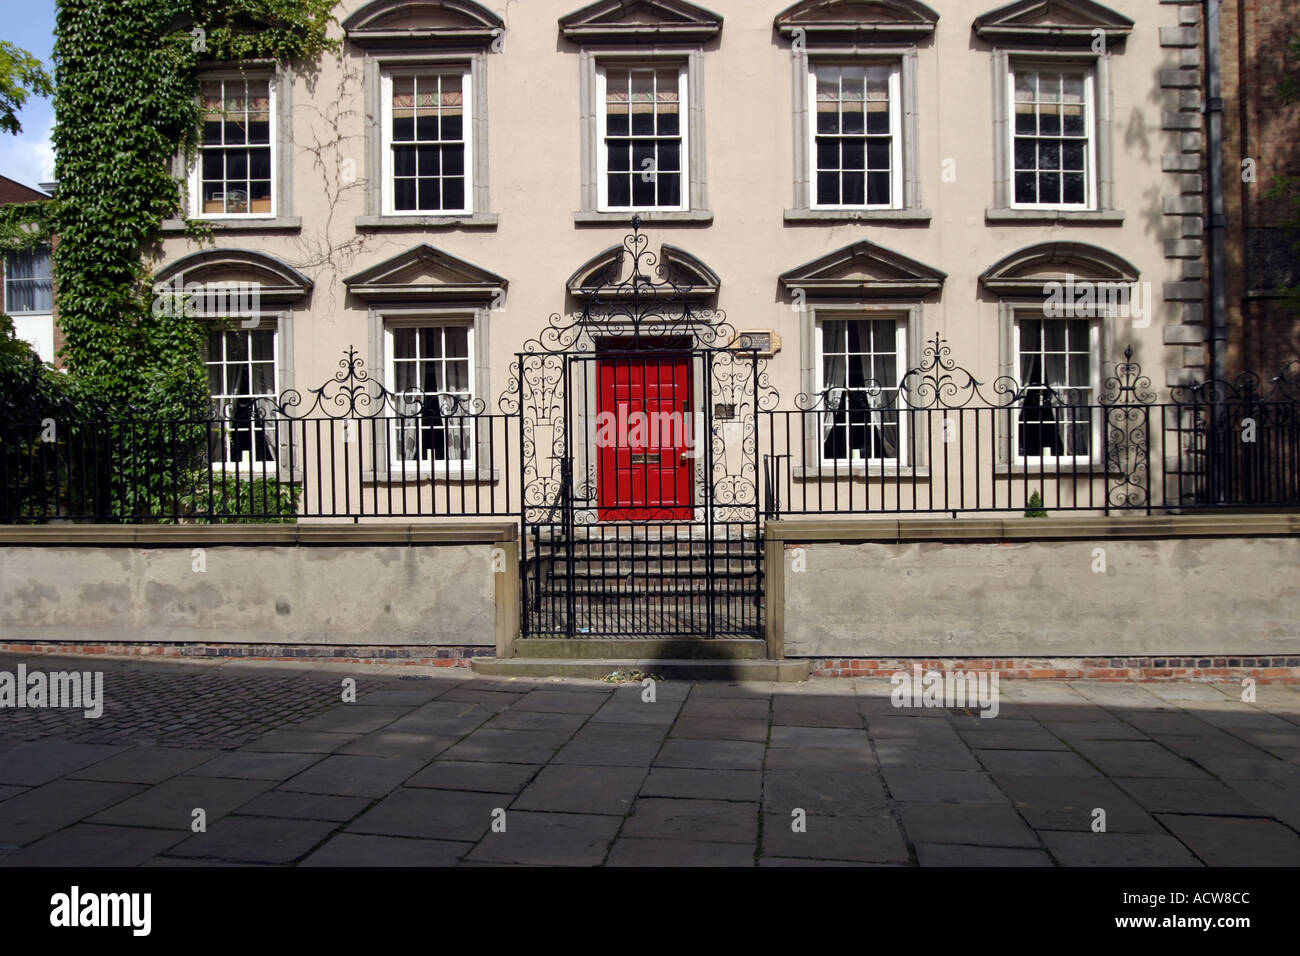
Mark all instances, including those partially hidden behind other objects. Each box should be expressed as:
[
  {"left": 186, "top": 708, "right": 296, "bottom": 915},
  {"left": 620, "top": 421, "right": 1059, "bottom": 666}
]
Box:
[{"left": 343, "top": 0, "right": 504, "bottom": 46}]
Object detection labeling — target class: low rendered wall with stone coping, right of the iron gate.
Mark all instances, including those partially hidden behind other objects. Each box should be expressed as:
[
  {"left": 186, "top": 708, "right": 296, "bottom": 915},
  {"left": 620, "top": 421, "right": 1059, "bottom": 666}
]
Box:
[{"left": 767, "top": 515, "right": 1300, "bottom": 667}]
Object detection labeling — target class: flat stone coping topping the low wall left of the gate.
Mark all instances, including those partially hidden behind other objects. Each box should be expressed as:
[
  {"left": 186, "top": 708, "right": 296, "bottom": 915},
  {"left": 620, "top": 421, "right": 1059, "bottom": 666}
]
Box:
[{"left": 0, "top": 522, "right": 519, "bottom": 548}]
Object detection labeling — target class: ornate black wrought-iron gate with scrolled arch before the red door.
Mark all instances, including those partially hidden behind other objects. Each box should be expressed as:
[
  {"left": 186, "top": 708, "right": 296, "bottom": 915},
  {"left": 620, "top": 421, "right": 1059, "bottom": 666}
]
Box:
[{"left": 501, "top": 219, "right": 776, "bottom": 637}]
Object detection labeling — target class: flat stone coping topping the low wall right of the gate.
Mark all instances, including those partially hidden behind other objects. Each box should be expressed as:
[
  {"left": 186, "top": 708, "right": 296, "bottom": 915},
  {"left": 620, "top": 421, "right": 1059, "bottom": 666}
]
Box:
[{"left": 767, "top": 514, "right": 1300, "bottom": 544}]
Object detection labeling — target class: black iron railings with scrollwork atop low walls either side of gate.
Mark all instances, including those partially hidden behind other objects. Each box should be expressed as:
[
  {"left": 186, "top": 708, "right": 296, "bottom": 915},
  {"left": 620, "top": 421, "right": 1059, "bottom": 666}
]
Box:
[{"left": 0, "top": 338, "right": 1300, "bottom": 522}]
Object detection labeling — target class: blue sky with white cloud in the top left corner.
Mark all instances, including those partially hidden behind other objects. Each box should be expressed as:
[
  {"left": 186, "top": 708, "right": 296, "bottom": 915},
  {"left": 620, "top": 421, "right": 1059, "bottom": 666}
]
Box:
[{"left": 0, "top": 0, "right": 55, "bottom": 187}]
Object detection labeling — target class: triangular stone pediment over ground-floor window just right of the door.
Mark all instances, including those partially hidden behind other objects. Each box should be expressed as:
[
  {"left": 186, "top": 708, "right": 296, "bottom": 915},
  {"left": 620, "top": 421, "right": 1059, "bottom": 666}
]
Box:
[{"left": 780, "top": 239, "right": 948, "bottom": 298}]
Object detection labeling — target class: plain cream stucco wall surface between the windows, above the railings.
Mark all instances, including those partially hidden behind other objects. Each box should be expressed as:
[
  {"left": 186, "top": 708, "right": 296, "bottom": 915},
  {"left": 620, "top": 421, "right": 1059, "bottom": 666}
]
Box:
[{"left": 157, "top": 0, "right": 1182, "bottom": 515}]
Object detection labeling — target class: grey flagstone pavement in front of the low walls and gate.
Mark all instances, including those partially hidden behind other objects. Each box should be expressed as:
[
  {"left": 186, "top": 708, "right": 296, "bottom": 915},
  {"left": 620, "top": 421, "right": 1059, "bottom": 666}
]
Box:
[{"left": 0, "top": 654, "right": 1300, "bottom": 866}]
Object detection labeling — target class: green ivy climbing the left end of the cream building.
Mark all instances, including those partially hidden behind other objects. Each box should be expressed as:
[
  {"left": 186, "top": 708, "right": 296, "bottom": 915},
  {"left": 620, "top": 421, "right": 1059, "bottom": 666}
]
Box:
[{"left": 0, "top": 0, "right": 338, "bottom": 518}]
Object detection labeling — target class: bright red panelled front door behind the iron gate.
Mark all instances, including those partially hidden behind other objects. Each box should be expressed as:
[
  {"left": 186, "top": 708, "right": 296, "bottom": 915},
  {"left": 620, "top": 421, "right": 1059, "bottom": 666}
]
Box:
[{"left": 595, "top": 352, "right": 696, "bottom": 522}]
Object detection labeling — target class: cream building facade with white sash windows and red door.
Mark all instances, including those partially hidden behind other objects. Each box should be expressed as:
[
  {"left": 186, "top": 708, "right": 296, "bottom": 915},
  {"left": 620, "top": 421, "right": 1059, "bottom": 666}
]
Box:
[{"left": 144, "top": 0, "right": 1227, "bottom": 530}]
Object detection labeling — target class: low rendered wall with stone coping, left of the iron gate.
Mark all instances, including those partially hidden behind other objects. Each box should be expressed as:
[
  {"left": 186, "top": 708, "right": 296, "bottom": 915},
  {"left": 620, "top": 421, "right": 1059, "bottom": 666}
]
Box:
[{"left": 0, "top": 523, "right": 519, "bottom": 652}]
